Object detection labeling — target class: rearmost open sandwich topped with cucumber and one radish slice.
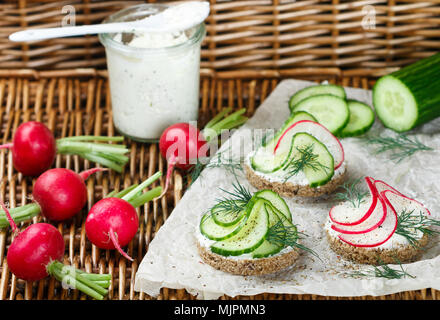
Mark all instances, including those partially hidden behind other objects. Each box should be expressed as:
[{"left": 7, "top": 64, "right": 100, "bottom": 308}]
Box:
[{"left": 244, "top": 111, "right": 346, "bottom": 197}]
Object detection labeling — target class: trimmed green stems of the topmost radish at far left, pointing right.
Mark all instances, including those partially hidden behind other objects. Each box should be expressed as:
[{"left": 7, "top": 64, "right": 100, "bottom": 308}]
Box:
[{"left": 56, "top": 136, "right": 129, "bottom": 172}]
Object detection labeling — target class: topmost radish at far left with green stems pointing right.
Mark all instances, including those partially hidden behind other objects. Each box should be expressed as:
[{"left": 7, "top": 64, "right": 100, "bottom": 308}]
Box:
[{"left": 0, "top": 121, "right": 128, "bottom": 176}]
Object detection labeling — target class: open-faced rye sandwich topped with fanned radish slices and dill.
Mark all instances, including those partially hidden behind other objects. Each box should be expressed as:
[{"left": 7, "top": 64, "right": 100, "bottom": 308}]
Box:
[{"left": 324, "top": 177, "right": 434, "bottom": 265}]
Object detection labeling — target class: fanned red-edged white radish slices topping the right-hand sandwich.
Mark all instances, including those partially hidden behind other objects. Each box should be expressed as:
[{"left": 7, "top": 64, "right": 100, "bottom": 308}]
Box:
[{"left": 329, "top": 177, "right": 431, "bottom": 247}]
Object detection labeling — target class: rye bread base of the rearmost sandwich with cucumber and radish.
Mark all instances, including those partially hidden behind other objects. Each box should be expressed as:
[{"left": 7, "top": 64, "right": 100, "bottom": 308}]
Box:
[{"left": 244, "top": 163, "right": 347, "bottom": 197}]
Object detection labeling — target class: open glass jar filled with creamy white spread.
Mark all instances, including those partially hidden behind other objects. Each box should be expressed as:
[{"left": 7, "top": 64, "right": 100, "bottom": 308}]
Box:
[{"left": 99, "top": 4, "right": 206, "bottom": 142}]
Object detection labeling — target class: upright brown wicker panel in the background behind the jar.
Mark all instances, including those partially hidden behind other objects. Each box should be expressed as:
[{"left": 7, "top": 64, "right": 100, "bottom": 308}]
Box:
[{"left": 0, "top": 0, "right": 440, "bottom": 76}]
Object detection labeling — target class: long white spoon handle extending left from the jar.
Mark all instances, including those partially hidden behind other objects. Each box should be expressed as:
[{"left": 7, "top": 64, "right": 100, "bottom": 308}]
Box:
[{"left": 9, "top": 22, "right": 136, "bottom": 42}]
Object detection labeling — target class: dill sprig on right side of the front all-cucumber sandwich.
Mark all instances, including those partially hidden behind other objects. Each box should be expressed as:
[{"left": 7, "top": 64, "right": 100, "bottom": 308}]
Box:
[{"left": 266, "top": 220, "right": 320, "bottom": 259}]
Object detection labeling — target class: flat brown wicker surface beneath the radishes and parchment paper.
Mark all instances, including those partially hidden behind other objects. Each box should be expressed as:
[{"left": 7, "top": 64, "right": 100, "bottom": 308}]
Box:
[{"left": 0, "top": 70, "right": 440, "bottom": 299}]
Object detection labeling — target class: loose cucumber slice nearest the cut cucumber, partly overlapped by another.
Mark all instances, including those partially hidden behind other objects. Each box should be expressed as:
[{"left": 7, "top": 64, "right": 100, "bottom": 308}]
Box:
[{"left": 338, "top": 100, "right": 374, "bottom": 138}]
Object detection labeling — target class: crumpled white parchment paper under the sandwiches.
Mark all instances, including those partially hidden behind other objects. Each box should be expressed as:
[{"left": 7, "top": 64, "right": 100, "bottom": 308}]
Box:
[{"left": 135, "top": 80, "right": 440, "bottom": 299}]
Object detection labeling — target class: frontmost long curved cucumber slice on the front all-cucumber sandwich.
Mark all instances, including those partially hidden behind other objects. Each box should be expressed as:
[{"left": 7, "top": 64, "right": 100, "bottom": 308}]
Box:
[{"left": 211, "top": 199, "right": 269, "bottom": 256}]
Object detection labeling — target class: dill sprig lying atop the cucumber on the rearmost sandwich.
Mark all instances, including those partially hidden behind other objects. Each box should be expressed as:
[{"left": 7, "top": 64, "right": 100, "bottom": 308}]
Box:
[{"left": 284, "top": 144, "right": 328, "bottom": 181}]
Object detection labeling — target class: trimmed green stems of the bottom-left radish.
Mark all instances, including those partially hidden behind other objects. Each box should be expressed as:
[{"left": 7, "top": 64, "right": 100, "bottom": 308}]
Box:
[{"left": 47, "top": 261, "right": 111, "bottom": 300}]
